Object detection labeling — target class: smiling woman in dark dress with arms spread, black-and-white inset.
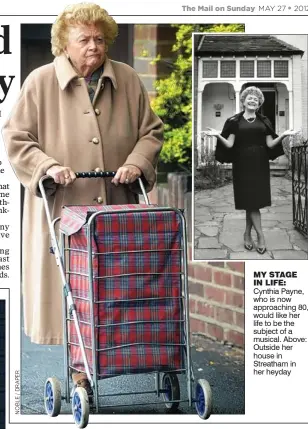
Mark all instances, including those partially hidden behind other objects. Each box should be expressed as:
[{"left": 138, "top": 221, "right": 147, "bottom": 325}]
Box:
[{"left": 206, "top": 86, "right": 294, "bottom": 255}]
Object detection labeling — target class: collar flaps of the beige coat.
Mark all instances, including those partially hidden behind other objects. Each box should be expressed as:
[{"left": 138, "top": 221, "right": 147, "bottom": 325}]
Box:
[{"left": 54, "top": 53, "right": 118, "bottom": 90}]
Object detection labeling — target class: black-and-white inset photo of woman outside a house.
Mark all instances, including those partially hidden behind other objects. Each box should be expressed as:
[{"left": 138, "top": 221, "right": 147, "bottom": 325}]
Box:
[{"left": 193, "top": 33, "right": 308, "bottom": 260}]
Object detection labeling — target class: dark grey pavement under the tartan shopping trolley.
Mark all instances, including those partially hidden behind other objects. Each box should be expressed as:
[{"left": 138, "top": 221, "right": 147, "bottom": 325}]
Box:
[{"left": 21, "top": 333, "right": 245, "bottom": 419}]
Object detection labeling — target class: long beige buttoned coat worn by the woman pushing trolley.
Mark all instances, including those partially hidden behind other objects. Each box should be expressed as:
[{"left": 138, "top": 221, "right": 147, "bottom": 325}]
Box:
[{"left": 2, "top": 55, "right": 163, "bottom": 344}]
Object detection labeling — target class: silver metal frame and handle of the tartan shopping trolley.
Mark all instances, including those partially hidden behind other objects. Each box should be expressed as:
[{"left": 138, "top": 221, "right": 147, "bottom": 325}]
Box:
[{"left": 39, "top": 172, "right": 195, "bottom": 413}]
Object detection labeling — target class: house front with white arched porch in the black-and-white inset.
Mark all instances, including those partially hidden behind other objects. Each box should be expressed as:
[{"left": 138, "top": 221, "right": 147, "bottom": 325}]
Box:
[{"left": 194, "top": 34, "right": 307, "bottom": 166}]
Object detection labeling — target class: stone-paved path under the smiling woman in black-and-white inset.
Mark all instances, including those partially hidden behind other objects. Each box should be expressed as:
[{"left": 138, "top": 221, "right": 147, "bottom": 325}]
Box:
[{"left": 194, "top": 177, "right": 308, "bottom": 260}]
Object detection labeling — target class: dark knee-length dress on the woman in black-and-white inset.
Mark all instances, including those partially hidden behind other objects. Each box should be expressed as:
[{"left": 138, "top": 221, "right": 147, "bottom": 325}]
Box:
[{"left": 229, "top": 116, "right": 271, "bottom": 210}]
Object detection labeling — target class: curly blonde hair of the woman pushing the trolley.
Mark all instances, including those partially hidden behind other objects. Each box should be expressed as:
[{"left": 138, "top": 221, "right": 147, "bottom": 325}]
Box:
[{"left": 51, "top": 3, "right": 118, "bottom": 57}]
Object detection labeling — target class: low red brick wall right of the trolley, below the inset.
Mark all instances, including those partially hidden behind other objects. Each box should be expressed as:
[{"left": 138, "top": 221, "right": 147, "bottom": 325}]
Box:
[{"left": 188, "top": 262, "right": 245, "bottom": 347}]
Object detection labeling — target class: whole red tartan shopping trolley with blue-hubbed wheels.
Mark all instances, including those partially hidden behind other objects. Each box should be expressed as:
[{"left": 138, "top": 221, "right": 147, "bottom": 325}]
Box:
[{"left": 40, "top": 172, "right": 212, "bottom": 427}]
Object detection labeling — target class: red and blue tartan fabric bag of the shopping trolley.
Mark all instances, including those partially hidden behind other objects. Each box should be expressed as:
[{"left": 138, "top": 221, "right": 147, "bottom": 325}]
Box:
[{"left": 60, "top": 205, "right": 184, "bottom": 377}]
